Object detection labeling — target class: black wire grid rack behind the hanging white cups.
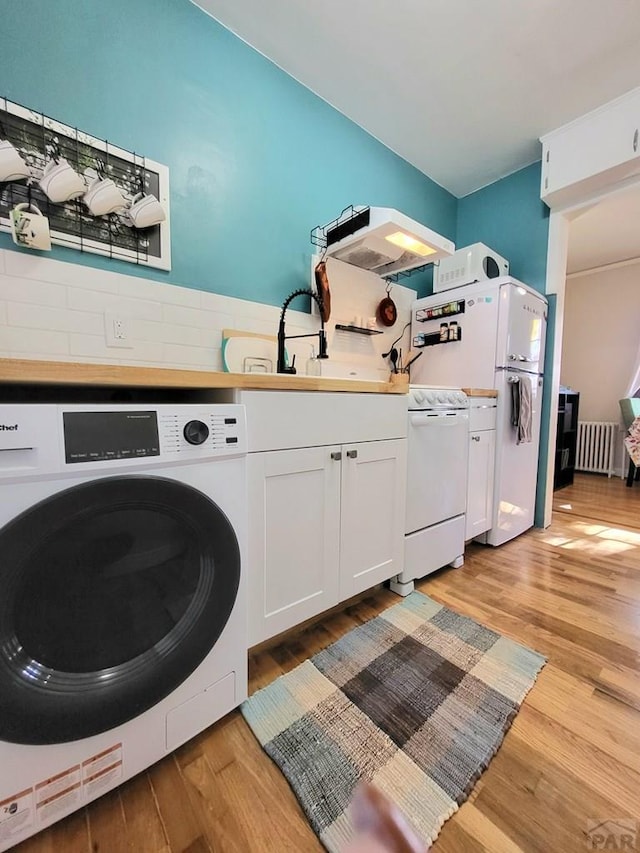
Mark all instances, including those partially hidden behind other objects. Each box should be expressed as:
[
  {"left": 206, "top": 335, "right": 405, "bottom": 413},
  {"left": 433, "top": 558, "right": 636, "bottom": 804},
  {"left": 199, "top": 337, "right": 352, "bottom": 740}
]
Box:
[{"left": 0, "top": 98, "right": 168, "bottom": 268}]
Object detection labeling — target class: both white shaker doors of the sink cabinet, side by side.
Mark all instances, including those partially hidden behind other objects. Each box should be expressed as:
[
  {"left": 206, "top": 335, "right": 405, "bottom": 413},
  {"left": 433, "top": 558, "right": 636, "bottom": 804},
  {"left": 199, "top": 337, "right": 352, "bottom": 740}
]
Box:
[{"left": 248, "top": 439, "right": 406, "bottom": 645}]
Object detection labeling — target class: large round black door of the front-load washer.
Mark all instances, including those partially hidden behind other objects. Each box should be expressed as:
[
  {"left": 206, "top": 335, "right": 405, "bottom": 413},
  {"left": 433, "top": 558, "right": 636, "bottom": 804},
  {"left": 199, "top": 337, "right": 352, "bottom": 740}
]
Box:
[{"left": 0, "top": 477, "right": 240, "bottom": 744}]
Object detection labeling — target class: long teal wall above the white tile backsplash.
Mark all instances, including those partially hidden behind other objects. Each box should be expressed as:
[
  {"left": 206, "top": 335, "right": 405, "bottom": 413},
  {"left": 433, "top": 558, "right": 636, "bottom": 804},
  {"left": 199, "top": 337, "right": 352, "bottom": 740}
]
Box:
[{"left": 0, "top": 0, "right": 457, "bottom": 305}]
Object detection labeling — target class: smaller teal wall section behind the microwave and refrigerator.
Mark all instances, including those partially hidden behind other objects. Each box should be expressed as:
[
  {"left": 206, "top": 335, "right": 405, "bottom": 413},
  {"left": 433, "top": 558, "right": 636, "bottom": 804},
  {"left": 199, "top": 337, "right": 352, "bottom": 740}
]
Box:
[{"left": 455, "top": 163, "right": 556, "bottom": 527}]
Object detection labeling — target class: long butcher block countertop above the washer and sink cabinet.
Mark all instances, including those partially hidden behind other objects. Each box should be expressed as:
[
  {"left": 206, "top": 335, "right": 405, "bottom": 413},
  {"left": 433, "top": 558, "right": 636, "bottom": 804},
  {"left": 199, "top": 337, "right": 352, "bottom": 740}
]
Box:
[{"left": 0, "top": 358, "right": 409, "bottom": 394}]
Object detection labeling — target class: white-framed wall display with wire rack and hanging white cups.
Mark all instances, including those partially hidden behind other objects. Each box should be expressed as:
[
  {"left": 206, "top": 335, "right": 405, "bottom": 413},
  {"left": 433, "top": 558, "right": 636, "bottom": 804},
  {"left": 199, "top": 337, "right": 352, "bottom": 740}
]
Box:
[{"left": 0, "top": 98, "right": 171, "bottom": 270}]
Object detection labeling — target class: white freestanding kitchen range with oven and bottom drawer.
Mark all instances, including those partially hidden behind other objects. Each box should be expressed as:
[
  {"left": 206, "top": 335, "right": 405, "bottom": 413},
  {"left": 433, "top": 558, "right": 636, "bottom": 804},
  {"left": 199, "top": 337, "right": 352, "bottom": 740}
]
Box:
[{"left": 391, "top": 385, "right": 469, "bottom": 595}]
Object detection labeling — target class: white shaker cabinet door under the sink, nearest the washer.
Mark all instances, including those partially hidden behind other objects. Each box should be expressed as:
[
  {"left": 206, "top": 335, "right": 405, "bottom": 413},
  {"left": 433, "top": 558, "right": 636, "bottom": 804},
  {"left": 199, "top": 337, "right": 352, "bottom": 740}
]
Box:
[{"left": 247, "top": 446, "right": 341, "bottom": 646}]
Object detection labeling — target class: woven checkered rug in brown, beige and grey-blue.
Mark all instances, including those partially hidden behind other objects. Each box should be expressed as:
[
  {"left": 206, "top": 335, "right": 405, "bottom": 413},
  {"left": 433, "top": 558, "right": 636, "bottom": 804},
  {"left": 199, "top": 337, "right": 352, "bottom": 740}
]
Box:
[{"left": 241, "top": 592, "right": 545, "bottom": 853}]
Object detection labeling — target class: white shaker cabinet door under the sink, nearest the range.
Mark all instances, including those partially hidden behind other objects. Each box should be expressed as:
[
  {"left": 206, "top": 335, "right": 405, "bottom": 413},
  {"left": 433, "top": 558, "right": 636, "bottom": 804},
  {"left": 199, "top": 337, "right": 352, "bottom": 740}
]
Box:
[{"left": 340, "top": 439, "right": 407, "bottom": 600}]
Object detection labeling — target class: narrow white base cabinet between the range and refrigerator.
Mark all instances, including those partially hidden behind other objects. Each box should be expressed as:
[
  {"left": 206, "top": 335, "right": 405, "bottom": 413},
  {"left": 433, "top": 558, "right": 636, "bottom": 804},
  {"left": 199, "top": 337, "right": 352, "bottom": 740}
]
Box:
[{"left": 465, "top": 397, "right": 497, "bottom": 541}]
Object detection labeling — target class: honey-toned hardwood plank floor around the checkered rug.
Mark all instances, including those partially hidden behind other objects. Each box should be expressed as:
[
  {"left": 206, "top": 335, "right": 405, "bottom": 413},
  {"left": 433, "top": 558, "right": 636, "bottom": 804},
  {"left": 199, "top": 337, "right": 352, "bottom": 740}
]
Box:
[{"left": 15, "top": 475, "right": 640, "bottom": 853}]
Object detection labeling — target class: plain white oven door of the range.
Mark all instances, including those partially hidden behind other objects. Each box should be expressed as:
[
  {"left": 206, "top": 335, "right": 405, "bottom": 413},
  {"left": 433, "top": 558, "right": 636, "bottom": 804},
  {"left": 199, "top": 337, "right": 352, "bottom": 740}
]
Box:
[{"left": 405, "top": 410, "right": 469, "bottom": 533}]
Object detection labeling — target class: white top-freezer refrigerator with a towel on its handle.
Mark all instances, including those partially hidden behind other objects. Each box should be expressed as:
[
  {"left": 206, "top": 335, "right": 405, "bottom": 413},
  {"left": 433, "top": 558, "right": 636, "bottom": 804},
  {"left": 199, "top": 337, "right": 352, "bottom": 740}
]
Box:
[{"left": 411, "top": 276, "right": 547, "bottom": 545}]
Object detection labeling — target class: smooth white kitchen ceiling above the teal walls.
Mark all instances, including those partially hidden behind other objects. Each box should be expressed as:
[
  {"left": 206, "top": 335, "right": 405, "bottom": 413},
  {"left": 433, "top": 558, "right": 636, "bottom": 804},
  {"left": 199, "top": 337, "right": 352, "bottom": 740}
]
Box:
[{"left": 194, "top": 0, "right": 640, "bottom": 197}]
